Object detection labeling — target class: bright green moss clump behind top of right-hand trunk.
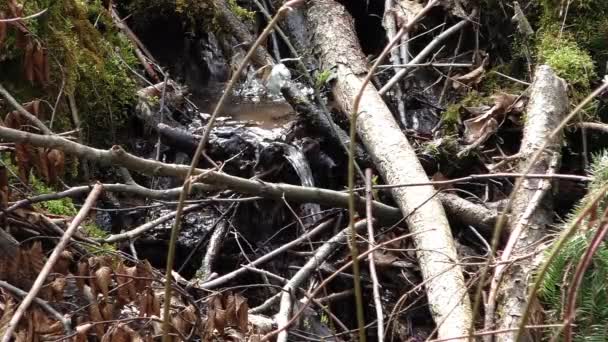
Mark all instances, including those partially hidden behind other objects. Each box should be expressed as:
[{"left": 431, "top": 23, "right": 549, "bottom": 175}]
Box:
[{"left": 537, "top": 32, "right": 596, "bottom": 88}]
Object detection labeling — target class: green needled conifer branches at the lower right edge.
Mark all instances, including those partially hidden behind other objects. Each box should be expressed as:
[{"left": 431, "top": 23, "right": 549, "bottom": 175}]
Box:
[{"left": 539, "top": 151, "right": 608, "bottom": 341}]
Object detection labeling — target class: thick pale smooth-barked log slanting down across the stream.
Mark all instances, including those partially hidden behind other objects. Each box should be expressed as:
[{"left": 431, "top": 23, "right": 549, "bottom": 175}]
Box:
[{"left": 308, "top": 0, "right": 471, "bottom": 338}]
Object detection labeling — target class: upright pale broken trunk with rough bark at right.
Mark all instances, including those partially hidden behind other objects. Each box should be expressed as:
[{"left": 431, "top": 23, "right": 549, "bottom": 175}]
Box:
[{"left": 496, "top": 65, "right": 568, "bottom": 342}]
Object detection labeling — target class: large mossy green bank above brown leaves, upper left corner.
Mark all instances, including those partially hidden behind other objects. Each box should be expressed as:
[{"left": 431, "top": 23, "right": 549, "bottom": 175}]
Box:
[{"left": 0, "top": 0, "right": 139, "bottom": 144}]
